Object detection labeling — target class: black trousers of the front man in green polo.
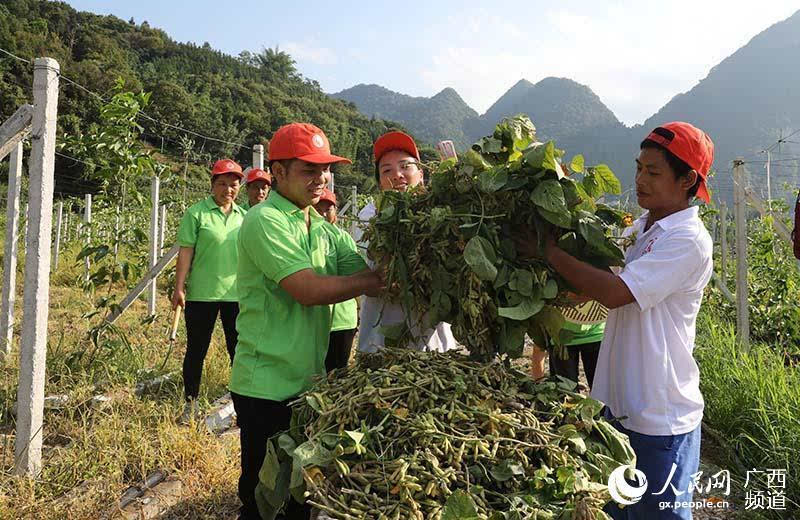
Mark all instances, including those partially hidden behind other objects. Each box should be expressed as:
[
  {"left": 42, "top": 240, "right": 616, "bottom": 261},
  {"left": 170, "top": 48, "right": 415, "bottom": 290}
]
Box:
[{"left": 231, "top": 392, "right": 311, "bottom": 520}]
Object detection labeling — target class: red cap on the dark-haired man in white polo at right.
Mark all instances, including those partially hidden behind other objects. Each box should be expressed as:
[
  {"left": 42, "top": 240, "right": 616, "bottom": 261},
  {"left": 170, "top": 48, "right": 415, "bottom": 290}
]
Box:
[{"left": 647, "top": 121, "right": 714, "bottom": 203}]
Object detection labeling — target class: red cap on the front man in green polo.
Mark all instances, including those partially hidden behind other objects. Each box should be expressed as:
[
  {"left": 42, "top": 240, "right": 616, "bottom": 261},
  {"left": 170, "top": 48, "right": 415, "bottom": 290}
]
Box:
[{"left": 269, "top": 123, "right": 352, "bottom": 164}]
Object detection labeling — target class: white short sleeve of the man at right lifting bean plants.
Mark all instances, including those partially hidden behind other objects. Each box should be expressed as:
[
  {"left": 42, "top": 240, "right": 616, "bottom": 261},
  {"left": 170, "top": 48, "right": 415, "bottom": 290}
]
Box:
[{"left": 619, "top": 236, "right": 703, "bottom": 311}]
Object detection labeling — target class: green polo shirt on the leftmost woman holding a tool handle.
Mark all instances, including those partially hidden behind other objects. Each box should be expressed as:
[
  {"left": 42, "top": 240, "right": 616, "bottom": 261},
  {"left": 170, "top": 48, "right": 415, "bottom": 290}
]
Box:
[{"left": 178, "top": 196, "right": 245, "bottom": 302}]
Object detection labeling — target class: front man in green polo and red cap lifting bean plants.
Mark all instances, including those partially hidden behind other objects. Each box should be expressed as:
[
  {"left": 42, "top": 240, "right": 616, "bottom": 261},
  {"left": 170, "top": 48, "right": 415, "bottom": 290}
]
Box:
[{"left": 230, "top": 123, "right": 384, "bottom": 520}]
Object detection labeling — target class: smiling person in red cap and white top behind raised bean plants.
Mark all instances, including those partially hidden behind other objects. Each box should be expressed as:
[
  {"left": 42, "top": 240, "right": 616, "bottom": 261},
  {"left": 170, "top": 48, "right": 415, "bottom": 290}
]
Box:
[{"left": 354, "top": 131, "right": 457, "bottom": 352}]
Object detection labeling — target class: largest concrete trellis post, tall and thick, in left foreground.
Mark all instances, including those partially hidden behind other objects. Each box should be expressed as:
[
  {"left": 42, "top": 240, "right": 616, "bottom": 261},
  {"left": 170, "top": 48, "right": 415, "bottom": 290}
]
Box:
[{"left": 14, "top": 58, "right": 59, "bottom": 477}]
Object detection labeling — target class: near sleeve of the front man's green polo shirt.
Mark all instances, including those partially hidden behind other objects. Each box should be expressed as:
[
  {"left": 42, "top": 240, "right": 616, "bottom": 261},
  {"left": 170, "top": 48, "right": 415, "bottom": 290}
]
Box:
[{"left": 240, "top": 215, "right": 313, "bottom": 284}]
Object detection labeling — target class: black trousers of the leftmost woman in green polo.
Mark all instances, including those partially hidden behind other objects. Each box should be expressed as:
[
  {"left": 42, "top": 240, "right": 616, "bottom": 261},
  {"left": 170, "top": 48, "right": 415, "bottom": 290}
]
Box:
[{"left": 183, "top": 301, "right": 239, "bottom": 399}]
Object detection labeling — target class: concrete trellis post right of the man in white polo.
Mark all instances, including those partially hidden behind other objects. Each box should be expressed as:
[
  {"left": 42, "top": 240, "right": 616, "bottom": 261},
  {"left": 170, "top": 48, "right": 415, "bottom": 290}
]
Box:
[{"left": 733, "top": 157, "right": 750, "bottom": 350}]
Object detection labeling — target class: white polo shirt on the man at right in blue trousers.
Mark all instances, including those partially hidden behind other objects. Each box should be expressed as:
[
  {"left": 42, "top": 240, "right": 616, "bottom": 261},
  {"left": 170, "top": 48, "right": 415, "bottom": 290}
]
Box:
[{"left": 592, "top": 207, "right": 713, "bottom": 435}]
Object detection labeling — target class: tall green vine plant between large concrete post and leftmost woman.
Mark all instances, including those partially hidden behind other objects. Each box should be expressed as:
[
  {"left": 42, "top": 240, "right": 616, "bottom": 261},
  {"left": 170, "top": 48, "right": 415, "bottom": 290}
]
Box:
[{"left": 61, "top": 79, "right": 166, "bottom": 368}]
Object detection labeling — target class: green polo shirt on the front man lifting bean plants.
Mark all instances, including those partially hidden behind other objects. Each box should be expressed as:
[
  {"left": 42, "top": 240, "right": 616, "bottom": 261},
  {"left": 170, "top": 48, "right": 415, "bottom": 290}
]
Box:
[{"left": 230, "top": 191, "right": 367, "bottom": 401}]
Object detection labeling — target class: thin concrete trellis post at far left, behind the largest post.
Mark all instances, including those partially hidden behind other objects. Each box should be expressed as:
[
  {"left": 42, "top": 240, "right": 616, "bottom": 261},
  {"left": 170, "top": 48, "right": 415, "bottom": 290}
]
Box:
[{"left": 0, "top": 141, "right": 22, "bottom": 361}]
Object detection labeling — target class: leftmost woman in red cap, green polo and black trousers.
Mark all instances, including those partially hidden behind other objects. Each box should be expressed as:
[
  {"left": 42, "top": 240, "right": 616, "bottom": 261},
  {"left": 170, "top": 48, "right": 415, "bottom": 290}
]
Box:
[{"left": 172, "top": 159, "right": 245, "bottom": 414}]
